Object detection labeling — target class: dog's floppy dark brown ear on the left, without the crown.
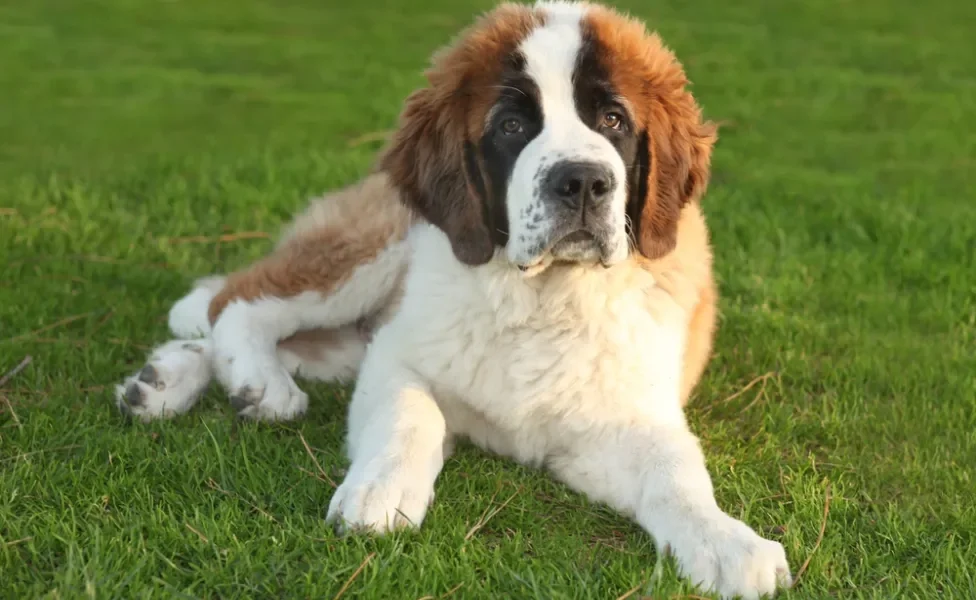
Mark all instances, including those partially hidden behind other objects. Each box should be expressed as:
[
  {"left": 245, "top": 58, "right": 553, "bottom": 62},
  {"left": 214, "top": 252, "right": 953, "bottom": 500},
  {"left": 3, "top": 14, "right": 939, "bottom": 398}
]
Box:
[{"left": 380, "top": 86, "right": 495, "bottom": 265}]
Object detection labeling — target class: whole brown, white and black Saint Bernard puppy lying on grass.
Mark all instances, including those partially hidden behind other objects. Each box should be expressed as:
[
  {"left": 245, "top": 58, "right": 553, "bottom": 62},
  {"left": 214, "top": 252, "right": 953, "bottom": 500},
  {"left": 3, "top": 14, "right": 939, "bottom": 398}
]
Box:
[{"left": 116, "top": 2, "right": 790, "bottom": 598}]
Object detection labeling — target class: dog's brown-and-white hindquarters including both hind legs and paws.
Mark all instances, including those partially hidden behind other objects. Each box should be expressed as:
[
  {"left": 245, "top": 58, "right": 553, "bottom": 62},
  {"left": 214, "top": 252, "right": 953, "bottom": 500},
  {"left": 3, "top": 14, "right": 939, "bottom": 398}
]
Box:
[{"left": 116, "top": 174, "right": 412, "bottom": 420}]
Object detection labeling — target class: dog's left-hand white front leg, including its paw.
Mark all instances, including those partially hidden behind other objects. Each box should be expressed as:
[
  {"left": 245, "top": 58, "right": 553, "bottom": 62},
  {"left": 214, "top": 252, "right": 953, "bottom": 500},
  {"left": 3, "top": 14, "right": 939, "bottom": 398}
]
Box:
[{"left": 328, "top": 348, "right": 447, "bottom": 533}]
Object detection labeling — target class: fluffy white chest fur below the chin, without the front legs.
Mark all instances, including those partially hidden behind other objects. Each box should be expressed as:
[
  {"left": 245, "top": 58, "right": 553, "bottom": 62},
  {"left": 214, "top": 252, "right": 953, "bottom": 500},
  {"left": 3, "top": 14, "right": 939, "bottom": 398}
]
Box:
[{"left": 376, "top": 226, "right": 687, "bottom": 463}]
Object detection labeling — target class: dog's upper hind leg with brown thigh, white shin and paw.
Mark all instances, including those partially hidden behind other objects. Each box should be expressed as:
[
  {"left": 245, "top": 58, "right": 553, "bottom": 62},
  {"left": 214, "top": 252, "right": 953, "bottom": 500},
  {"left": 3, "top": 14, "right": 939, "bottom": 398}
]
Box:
[{"left": 209, "top": 174, "right": 412, "bottom": 420}]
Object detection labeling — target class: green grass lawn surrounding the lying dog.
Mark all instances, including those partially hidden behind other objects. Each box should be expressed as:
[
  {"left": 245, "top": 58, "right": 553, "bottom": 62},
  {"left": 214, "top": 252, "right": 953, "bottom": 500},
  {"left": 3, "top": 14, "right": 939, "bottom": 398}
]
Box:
[{"left": 0, "top": 0, "right": 976, "bottom": 599}]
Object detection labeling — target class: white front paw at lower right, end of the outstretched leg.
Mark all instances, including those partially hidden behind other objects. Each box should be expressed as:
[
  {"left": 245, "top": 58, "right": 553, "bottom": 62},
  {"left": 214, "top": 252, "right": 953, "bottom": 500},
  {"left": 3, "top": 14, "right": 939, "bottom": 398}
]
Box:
[{"left": 671, "top": 513, "right": 792, "bottom": 600}]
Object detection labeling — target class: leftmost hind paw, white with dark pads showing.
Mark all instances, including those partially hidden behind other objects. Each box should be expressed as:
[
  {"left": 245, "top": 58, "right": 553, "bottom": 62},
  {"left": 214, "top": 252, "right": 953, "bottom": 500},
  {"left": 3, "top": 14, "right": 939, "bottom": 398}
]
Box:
[{"left": 115, "top": 339, "right": 211, "bottom": 422}]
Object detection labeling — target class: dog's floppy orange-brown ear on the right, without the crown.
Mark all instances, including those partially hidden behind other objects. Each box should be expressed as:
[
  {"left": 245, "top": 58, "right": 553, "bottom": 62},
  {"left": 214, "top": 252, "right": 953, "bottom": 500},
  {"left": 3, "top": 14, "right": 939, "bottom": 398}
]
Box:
[{"left": 628, "top": 89, "right": 718, "bottom": 259}]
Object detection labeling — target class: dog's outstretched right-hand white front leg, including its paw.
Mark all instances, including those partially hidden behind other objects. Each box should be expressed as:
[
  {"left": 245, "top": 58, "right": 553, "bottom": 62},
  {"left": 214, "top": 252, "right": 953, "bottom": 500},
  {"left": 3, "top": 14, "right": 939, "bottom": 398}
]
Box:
[{"left": 550, "top": 422, "right": 790, "bottom": 598}]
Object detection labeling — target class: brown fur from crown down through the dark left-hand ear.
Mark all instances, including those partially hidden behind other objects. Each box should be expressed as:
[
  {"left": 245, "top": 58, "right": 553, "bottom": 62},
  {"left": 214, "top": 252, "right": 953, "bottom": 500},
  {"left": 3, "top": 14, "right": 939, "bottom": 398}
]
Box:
[{"left": 380, "top": 4, "right": 542, "bottom": 265}]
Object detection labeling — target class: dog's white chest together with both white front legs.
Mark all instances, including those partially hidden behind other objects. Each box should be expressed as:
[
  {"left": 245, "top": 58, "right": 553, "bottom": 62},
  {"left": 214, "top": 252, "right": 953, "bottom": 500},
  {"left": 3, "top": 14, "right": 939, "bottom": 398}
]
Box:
[{"left": 329, "top": 226, "right": 790, "bottom": 598}]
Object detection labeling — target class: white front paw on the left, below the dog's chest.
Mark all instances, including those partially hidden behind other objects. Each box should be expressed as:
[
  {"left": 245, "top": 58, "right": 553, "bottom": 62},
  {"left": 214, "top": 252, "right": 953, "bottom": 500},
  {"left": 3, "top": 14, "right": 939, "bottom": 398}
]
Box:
[{"left": 326, "top": 459, "right": 437, "bottom": 533}]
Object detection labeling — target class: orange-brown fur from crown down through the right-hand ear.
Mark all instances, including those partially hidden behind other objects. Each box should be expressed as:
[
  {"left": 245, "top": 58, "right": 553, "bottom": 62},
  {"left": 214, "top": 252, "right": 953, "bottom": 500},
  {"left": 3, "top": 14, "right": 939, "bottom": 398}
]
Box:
[{"left": 584, "top": 6, "right": 717, "bottom": 258}]
